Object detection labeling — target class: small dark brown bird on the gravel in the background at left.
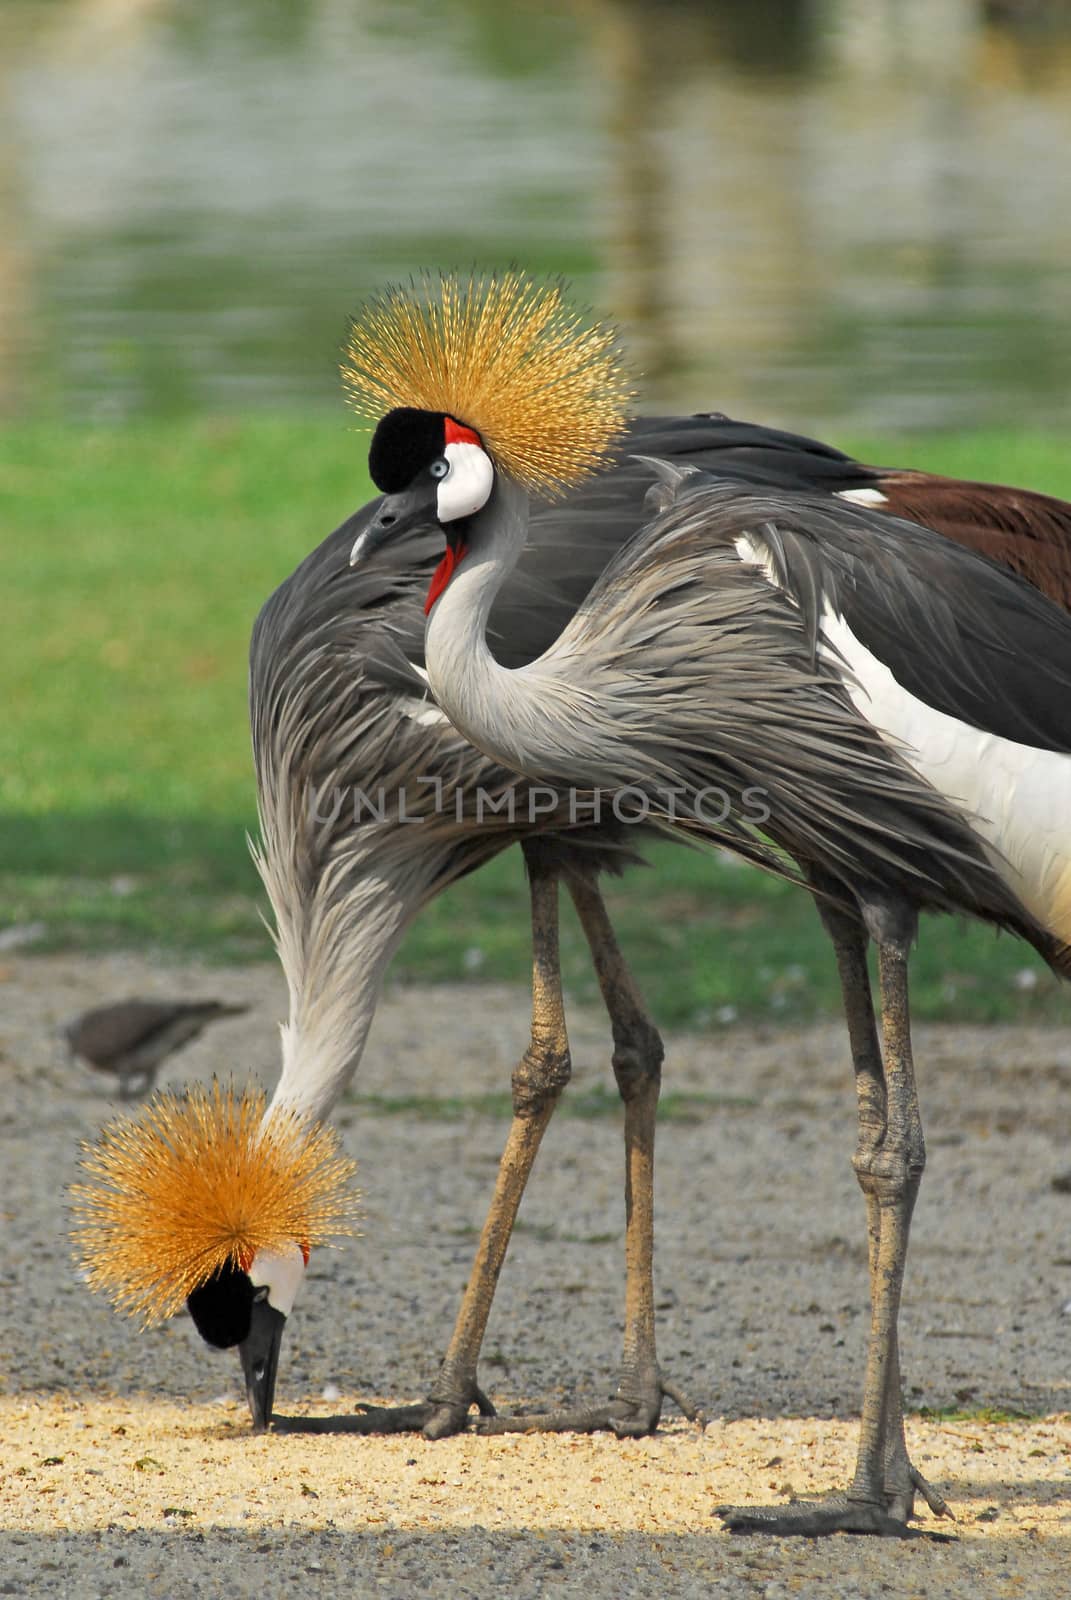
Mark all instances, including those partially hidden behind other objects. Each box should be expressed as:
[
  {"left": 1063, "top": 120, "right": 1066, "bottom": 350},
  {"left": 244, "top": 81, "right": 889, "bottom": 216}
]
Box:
[{"left": 64, "top": 1000, "right": 250, "bottom": 1099}]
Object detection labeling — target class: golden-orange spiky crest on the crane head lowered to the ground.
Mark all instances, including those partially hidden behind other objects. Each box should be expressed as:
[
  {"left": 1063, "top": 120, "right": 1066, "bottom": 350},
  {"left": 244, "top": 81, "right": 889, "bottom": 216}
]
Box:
[{"left": 70, "top": 1083, "right": 357, "bottom": 1325}]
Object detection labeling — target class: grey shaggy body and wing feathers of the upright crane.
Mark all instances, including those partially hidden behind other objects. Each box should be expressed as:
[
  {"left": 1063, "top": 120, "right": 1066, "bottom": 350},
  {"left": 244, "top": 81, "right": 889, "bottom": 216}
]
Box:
[{"left": 560, "top": 474, "right": 1071, "bottom": 973}]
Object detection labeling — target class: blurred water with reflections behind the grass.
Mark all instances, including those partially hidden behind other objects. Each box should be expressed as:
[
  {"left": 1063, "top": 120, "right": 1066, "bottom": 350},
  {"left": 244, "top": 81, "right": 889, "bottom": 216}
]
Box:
[{"left": 0, "top": 0, "right": 1071, "bottom": 434}]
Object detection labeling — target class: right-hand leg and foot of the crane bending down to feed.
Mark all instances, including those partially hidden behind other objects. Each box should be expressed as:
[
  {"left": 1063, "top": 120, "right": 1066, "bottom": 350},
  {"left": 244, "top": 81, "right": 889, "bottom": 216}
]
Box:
[{"left": 477, "top": 872, "right": 700, "bottom": 1437}]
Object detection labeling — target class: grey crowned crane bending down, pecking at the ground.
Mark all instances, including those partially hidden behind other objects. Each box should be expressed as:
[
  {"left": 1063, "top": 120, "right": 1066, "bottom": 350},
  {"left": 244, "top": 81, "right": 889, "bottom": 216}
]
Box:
[{"left": 80, "top": 334, "right": 1071, "bottom": 1465}]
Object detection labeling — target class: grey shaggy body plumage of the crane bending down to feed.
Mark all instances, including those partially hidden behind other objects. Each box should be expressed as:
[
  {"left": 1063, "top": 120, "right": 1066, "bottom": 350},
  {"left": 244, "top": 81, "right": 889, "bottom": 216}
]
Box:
[{"left": 250, "top": 416, "right": 1071, "bottom": 1100}]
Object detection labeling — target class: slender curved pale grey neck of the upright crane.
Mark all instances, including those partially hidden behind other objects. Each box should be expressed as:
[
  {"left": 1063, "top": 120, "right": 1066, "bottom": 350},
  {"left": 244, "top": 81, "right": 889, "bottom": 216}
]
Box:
[{"left": 424, "top": 474, "right": 543, "bottom": 771}]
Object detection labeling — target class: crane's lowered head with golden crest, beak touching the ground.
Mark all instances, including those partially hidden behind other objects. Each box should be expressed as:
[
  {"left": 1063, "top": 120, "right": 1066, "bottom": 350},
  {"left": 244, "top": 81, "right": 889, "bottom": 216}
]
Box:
[{"left": 72, "top": 1083, "right": 357, "bottom": 1432}]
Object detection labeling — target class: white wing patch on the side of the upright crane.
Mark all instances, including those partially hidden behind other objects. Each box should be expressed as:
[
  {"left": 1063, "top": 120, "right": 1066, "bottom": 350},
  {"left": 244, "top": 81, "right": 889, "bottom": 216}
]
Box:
[{"left": 821, "top": 606, "right": 1071, "bottom": 942}]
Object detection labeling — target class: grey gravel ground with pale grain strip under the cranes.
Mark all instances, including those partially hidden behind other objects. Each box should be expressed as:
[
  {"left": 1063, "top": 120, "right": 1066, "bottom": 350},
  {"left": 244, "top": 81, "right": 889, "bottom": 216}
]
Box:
[{"left": 0, "top": 957, "right": 1071, "bottom": 1600}]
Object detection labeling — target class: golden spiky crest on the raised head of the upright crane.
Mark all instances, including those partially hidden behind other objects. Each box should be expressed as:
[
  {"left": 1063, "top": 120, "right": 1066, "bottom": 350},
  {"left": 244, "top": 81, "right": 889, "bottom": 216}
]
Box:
[{"left": 341, "top": 270, "right": 631, "bottom": 494}]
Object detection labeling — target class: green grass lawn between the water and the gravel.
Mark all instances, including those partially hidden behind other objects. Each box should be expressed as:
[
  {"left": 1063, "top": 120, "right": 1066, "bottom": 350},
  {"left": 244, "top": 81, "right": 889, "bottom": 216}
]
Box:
[{"left": 0, "top": 416, "right": 1071, "bottom": 1024}]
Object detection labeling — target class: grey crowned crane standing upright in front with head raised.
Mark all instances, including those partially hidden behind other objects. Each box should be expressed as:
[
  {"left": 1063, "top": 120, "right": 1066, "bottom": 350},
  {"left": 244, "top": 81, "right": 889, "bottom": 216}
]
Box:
[{"left": 347, "top": 274, "right": 1071, "bottom": 1536}]
